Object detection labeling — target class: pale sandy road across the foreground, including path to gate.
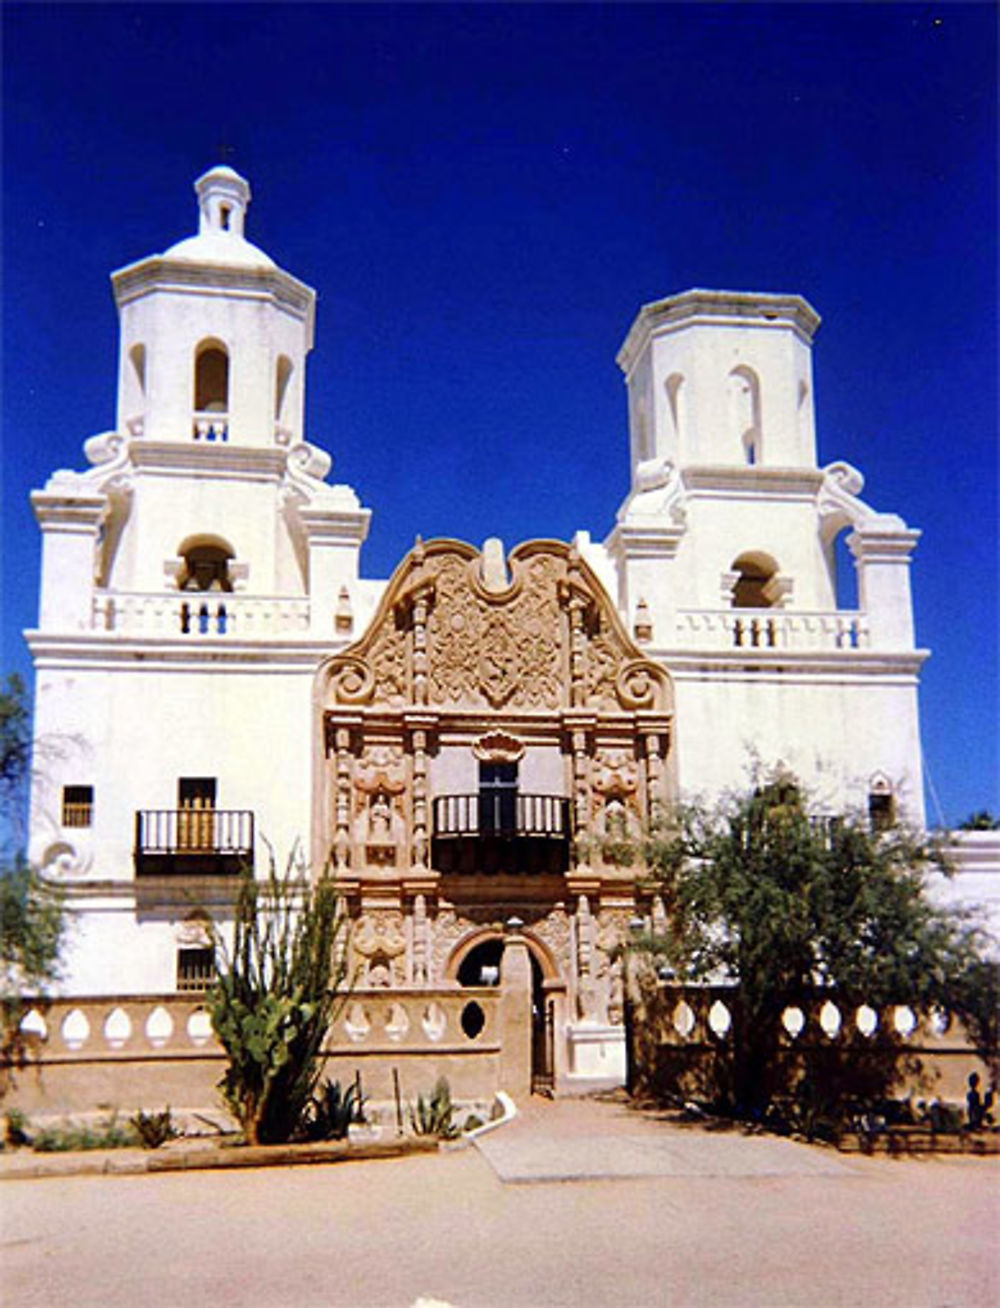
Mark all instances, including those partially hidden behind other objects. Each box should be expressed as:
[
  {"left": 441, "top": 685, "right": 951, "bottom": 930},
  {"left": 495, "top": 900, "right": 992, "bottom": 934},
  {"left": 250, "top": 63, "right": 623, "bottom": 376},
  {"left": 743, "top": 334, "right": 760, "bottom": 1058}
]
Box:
[{"left": 0, "top": 1104, "right": 1000, "bottom": 1308}]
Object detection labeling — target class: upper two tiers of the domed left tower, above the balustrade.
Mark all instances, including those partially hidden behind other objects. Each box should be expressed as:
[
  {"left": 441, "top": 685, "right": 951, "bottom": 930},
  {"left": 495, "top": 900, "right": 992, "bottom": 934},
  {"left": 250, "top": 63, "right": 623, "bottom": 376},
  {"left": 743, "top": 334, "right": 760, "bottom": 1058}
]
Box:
[{"left": 33, "top": 166, "right": 370, "bottom": 617}]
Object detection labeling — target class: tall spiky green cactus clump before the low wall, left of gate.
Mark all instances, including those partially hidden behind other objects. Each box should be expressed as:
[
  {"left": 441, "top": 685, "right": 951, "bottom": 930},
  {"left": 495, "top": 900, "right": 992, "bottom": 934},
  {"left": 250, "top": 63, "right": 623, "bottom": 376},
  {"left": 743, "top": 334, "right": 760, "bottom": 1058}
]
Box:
[{"left": 207, "top": 857, "right": 349, "bottom": 1145}]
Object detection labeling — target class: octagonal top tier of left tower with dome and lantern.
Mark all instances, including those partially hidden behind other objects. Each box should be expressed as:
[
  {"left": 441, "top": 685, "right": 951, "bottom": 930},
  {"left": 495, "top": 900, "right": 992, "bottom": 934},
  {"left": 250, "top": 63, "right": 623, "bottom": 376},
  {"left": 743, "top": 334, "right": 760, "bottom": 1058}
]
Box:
[{"left": 111, "top": 166, "right": 316, "bottom": 449}]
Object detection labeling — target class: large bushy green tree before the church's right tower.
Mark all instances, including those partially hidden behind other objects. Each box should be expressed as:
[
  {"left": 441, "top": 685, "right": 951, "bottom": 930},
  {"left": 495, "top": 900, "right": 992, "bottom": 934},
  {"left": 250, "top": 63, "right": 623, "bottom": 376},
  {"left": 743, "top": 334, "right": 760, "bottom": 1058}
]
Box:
[{"left": 635, "top": 772, "right": 996, "bottom": 1117}]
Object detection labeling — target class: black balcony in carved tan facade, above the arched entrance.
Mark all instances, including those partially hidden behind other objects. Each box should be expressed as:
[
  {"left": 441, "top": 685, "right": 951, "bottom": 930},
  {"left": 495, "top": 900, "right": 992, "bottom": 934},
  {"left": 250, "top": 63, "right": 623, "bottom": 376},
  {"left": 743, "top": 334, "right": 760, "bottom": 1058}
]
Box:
[{"left": 431, "top": 790, "right": 571, "bottom": 875}]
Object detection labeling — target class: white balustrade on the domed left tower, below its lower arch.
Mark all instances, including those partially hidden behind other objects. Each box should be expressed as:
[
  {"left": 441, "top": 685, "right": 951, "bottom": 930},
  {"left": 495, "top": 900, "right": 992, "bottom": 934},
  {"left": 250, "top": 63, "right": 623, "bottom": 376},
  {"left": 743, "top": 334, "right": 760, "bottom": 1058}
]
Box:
[{"left": 93, "top": 590, "right": 308, "bottom": 640}]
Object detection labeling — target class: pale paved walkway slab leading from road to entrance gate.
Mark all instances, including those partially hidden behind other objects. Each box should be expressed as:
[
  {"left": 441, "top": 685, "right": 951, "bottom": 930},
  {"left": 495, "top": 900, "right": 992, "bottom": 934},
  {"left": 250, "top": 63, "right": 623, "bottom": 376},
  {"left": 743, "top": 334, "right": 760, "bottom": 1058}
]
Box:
[{"left": 477, "top": 1099, "right": 851, "bottom": 1182}]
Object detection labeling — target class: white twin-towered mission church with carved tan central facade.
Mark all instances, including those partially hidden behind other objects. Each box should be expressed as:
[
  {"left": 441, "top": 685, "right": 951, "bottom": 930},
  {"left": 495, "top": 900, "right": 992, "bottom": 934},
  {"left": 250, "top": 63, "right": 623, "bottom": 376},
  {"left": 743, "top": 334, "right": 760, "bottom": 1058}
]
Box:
[{"left": 27, "top": 167, "right": 984, "bottom": 1093}]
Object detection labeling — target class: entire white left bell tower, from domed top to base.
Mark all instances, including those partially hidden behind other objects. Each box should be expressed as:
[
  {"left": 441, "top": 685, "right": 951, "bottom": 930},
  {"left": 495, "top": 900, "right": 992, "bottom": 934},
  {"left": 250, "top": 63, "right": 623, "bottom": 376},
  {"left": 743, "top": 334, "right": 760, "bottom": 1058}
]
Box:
[{"left": 27, "top": 166, "right": 380, "bottom": 993}]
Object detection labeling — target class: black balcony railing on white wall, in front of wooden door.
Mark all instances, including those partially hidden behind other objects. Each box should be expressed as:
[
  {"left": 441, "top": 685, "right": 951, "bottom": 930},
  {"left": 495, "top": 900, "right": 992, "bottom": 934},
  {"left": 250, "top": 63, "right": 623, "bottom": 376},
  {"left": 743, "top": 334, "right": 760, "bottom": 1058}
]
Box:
[{"left": 135, "top": 808, "right": 254, "bottom": 876}]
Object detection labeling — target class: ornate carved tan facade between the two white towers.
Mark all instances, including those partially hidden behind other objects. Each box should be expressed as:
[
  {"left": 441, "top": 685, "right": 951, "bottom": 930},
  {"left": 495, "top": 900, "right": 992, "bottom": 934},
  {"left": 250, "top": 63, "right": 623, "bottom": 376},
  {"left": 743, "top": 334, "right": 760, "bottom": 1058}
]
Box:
[{"left": 314, "top": 540, "right": 673, "bottom": 1023}]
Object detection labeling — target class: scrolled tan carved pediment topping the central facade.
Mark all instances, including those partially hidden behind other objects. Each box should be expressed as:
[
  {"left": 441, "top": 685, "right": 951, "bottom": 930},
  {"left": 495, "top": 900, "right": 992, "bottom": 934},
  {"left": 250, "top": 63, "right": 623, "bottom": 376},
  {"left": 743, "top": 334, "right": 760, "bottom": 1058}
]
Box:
[{"left": 322, "top": 540, "right": 672, "bottom": 713}]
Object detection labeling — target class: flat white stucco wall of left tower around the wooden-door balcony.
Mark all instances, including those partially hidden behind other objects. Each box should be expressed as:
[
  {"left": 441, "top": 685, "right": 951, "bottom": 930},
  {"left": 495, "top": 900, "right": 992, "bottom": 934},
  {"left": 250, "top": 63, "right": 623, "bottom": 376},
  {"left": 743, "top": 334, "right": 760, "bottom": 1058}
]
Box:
[{"left": 30, "top": 658, "right": 312, "bottom": 880}]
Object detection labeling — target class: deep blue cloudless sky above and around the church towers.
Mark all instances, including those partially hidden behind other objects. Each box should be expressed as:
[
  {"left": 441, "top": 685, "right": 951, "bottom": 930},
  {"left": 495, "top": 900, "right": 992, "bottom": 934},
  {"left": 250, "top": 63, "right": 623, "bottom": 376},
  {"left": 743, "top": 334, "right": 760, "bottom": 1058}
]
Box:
[{"left": 3, "top": 4, "right": 1000, "bottom": 821}]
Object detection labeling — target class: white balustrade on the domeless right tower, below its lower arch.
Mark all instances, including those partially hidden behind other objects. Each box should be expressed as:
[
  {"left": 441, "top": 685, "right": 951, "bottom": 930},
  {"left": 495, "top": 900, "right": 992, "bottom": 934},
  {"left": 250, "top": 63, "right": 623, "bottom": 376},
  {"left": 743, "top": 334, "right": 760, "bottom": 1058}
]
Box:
[{"left": 676, "top": 608, "right": 871, "bottom": 651}]
